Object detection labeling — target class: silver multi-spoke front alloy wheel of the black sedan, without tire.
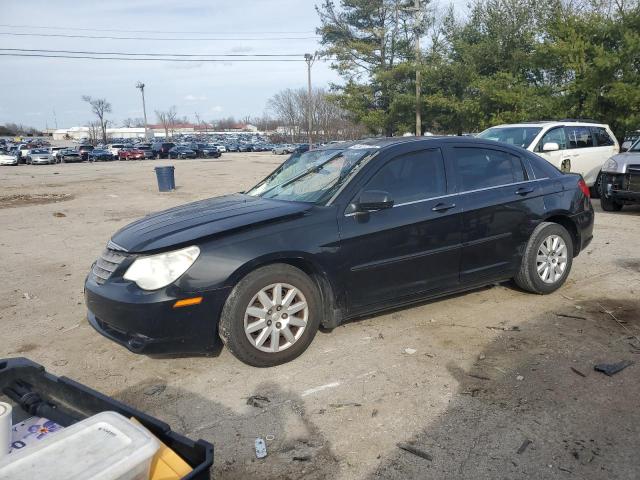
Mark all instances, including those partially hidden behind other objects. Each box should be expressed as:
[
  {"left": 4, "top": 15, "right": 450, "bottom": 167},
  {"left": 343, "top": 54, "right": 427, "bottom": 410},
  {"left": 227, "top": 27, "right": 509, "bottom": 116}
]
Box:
[{"left": 244, "top": 283, "right": 309, "bottom": 353}]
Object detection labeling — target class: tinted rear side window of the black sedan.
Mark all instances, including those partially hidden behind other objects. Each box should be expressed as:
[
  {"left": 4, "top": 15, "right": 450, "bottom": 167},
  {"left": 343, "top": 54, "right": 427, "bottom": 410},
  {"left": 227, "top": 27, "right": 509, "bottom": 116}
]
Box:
[{"left": 454, "top": 147, "right": 527, "bottom": 192}]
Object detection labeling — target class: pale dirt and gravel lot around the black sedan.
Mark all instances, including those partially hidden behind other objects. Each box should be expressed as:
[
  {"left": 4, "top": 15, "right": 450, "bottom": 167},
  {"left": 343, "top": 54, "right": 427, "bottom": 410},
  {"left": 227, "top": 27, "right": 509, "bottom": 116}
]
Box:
[{"left": 0, "top": 153, "right": 640, "bottom": 479}]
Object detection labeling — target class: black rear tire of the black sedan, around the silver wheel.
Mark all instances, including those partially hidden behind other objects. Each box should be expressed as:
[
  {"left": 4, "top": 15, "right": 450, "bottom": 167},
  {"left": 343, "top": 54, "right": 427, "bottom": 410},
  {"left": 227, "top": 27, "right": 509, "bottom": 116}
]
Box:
[{"left": 514, "top": 222, "right": 573, "bottom": 295}]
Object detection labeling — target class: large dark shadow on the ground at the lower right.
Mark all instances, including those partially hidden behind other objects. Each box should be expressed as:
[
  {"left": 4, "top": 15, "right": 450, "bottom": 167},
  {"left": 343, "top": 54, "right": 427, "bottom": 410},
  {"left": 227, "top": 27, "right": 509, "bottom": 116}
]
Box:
[{"left": 369, "top": 298, "right": 640, "bottom": 479}]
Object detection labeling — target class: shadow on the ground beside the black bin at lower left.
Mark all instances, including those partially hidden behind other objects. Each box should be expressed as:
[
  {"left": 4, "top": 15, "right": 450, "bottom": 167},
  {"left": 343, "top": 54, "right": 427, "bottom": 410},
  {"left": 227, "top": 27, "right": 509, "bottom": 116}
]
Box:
[{"left": 114, "top": 378, "right": 338, "bottom": 480}]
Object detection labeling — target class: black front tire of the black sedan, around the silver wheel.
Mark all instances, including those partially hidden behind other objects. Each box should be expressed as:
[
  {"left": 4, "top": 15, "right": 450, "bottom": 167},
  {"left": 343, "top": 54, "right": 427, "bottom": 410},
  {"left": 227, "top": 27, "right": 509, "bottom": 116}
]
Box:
[{"left": 218, "top": 264, "right": 321, "bottom": 367}]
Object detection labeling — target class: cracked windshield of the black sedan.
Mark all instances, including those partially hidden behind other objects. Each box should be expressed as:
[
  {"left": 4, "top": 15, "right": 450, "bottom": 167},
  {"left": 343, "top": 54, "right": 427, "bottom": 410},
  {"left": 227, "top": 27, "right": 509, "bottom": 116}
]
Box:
[{"left": 247, "top": 148, "right": 375, "bottom": 203}]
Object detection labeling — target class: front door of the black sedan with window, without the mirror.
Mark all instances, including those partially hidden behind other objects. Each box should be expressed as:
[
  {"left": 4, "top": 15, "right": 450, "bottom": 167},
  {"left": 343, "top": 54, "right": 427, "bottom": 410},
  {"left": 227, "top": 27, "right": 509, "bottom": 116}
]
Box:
[{"left": 339, "top": 147, "right": 461, "bottom": 312}]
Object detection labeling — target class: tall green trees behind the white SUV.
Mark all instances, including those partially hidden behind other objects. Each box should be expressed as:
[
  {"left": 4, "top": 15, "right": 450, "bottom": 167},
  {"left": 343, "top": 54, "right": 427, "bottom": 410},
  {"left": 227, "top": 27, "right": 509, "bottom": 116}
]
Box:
[{"left": 316, "top": 0, "right": 640, "bottom": 136}]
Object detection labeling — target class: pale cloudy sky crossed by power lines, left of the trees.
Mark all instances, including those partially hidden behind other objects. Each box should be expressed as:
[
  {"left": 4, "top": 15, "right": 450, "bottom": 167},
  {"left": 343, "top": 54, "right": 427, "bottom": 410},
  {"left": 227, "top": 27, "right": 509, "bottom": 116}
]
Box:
[{"left": 0, "top": 0, "right": 462, "bottom": 128}]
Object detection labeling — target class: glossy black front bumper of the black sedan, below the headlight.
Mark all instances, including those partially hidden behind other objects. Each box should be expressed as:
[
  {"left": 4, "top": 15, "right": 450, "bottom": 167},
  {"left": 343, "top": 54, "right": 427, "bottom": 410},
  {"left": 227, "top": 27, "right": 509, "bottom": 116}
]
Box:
[{"left": 85, "top": 276, "right": 229, "bottom": 355}]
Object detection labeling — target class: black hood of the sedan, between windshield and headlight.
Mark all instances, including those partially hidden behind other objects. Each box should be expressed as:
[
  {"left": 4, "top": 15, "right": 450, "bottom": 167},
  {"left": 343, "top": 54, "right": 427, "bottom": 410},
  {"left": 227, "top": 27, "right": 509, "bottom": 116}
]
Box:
[{"left": 111, "top": 194, "right": 311, "bottom": 253}]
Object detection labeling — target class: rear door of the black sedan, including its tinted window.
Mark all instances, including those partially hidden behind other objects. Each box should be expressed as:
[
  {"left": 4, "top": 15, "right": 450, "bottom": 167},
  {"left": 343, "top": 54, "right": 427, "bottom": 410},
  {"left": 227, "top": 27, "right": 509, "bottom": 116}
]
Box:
[{"left": 446, "top": 143, "right": 544, "bottom": 285}]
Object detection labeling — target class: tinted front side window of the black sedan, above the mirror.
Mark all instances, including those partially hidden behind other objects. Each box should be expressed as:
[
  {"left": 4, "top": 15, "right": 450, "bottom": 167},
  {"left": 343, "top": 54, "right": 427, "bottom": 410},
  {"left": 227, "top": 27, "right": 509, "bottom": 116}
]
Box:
[{"left": 364, "top": 150, "right": 447, "bottom": 205}]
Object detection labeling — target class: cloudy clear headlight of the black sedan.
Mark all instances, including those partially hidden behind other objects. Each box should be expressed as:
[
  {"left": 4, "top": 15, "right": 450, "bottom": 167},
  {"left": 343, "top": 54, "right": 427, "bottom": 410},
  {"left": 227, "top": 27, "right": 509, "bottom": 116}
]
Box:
[{"left": 124, "top": 246, "right": 200, "bottom": 290}]
